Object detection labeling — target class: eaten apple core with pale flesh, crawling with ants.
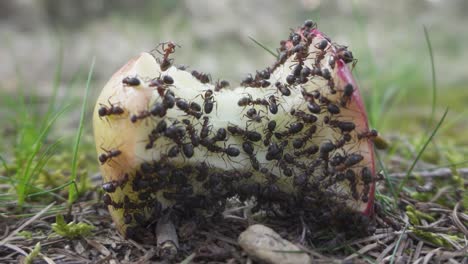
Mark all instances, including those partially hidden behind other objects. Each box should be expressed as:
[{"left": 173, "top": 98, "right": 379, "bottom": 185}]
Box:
[{"left": 94, "top": 24, "right": 375, "bottom": 237}]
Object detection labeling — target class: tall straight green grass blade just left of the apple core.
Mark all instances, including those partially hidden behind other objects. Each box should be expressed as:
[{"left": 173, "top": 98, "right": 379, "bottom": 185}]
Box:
[{"left": 68, "top": 58, "right": 95, "bottom": 205}]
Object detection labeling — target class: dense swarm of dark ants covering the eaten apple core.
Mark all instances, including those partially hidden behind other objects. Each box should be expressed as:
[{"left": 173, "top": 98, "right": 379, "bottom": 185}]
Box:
[{"left": 95, "top": 21, "right": 378, "bottom": 238}]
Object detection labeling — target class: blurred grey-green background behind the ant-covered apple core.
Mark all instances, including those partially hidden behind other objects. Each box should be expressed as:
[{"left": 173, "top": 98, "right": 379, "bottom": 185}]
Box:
[{"left": 0, "top": 0, "right": 468, "bottom": 160}]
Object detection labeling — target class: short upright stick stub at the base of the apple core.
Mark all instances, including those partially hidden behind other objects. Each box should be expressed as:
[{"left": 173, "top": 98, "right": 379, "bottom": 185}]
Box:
[{"left": 156, "top": 211, "right": 179, "bottom": 259}]
